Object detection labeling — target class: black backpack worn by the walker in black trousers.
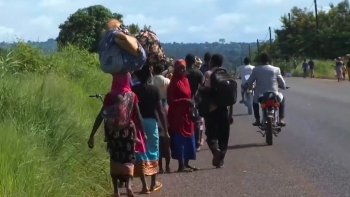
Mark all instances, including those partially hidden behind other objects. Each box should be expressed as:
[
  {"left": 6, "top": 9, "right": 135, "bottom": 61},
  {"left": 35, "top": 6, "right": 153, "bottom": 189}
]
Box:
[{"left": 210, "top": 68, "right": 237, "bottom": 107}]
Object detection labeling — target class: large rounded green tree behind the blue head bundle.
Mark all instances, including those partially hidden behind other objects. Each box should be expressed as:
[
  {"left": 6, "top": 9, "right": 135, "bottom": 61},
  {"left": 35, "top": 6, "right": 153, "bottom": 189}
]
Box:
[{"left": 56, "top": 5, "right": 123, "bottom": 52}]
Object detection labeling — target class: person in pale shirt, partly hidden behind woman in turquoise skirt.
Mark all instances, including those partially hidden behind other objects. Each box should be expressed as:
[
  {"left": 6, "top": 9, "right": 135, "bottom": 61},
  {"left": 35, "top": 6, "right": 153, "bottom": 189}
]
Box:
[{"left": 153, "top": 65, "right": 171, "bottom": 174}]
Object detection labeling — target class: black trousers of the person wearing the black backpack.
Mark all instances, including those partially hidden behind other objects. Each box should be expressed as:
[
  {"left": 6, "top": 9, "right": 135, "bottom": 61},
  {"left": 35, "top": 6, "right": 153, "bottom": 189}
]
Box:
[{"left": 204, "top": 107, "right": 230, "bottom": 160}]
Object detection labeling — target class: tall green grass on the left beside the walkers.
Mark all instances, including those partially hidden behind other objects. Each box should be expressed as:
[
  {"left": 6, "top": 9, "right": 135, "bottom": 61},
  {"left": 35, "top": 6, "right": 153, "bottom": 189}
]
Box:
[{"left": 0, "top": 43, "right": 115, "bottom": 197}]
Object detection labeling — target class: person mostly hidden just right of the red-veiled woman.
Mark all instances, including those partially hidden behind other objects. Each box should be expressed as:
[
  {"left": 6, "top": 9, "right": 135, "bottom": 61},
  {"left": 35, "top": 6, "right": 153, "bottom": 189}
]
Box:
[{"left": 185, "top": 54, "right": 204, "bottom": 151}]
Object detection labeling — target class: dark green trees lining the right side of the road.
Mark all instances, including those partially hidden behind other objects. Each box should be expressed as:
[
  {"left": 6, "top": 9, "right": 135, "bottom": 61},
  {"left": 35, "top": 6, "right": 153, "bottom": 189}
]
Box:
[{"left": 259, "top": 0, "right": 350, "bottom": 60}]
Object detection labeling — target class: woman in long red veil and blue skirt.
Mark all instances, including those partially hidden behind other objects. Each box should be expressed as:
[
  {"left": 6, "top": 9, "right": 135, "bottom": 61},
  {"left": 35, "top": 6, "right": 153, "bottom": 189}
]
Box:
[{"left": 167, "top": 59, "right": 198, "bottom": 172}]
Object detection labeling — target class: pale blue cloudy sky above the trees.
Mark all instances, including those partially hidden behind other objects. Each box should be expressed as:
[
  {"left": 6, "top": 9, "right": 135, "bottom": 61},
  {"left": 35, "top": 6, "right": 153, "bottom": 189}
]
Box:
[{"left": 0, "top": 0, "right": 339, "bottom": 42}]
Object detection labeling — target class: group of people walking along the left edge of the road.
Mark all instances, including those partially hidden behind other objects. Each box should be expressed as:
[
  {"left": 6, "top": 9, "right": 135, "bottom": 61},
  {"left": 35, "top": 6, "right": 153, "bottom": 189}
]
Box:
[{"left": 88, "top": 50, "right": 233, "bottom": 196}]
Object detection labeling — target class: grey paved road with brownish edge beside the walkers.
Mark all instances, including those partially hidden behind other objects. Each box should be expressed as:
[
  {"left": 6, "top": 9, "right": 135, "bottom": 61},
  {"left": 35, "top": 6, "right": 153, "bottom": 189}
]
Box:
[{"left": 129, "top": 78, "right": 350, "bottom": 197}]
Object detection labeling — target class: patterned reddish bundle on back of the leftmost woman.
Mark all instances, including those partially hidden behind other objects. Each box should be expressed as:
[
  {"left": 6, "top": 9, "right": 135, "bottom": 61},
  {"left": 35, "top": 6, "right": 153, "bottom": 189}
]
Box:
[{"left": 102, "top": 91, "right": 135, "bottom": 132}]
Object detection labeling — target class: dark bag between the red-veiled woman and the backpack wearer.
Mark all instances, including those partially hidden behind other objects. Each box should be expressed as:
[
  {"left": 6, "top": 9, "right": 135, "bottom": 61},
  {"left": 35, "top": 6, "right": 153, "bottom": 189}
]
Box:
[{"left": 194, "top": 87, "right": 211, "bottom": 117}]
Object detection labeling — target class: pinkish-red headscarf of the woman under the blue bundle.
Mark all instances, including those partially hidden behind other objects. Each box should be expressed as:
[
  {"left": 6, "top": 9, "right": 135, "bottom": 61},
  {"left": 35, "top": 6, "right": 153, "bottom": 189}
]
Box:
[{"left": 111, "top": 73, "right": 131, "bottom": 94}]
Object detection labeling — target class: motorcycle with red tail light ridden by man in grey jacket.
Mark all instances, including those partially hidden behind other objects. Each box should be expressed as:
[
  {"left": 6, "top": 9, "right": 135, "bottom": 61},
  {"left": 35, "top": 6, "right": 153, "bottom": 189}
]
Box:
[{"left": 257, "top": 87, "right": 290, "bottom": 146}]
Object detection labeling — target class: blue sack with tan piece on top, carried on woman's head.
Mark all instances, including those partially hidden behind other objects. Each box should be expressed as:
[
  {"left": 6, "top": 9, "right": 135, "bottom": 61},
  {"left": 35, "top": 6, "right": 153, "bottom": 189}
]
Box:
[{"left": 99, "top": 26, "right": 147, "bottom": 74}]
